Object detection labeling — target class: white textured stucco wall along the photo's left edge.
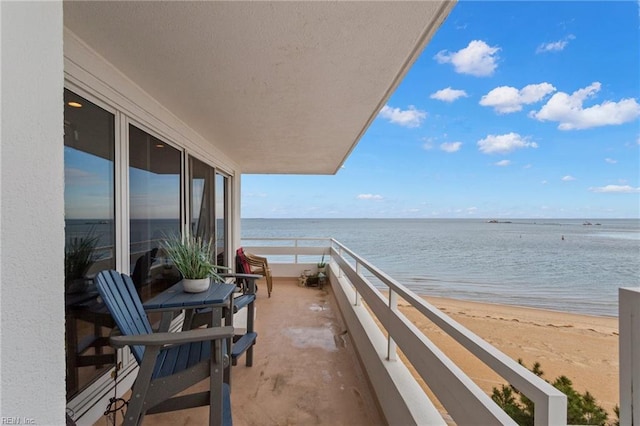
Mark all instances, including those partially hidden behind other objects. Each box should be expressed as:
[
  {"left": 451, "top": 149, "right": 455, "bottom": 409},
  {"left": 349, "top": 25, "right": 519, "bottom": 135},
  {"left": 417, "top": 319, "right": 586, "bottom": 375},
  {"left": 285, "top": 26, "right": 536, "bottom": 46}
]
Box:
[{"left": 0, "top": 1, "right": 65, "bottom": 425}]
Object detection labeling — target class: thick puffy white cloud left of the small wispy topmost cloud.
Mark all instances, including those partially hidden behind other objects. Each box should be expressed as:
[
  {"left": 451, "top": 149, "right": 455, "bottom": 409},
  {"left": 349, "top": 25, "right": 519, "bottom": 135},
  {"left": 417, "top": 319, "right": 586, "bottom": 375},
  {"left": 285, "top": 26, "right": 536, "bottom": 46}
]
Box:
[{"left": 434, "top": 40, "right": 500, "bottom": 77}]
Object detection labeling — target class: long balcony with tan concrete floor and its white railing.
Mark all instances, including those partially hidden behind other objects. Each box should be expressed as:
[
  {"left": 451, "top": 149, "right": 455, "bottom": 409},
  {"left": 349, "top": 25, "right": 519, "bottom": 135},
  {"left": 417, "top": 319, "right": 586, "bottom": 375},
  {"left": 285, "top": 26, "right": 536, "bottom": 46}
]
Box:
[{"left": 96, "top": 238, "right": 640, "bottom": 425}]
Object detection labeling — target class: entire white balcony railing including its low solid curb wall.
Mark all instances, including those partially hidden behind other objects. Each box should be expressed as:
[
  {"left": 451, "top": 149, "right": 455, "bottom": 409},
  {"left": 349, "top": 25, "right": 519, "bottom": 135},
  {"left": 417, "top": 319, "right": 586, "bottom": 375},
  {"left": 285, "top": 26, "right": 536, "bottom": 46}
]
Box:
[{"left": 243, "top": 238, "right": 568, "bottom": 425}]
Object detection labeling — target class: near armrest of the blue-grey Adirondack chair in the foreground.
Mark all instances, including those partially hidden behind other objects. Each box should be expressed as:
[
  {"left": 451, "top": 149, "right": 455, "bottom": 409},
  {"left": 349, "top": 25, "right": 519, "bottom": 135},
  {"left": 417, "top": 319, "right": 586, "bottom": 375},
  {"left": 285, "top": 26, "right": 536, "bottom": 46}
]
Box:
[{"left": 109, "top": 326, "right": 234, "bottom": 348}]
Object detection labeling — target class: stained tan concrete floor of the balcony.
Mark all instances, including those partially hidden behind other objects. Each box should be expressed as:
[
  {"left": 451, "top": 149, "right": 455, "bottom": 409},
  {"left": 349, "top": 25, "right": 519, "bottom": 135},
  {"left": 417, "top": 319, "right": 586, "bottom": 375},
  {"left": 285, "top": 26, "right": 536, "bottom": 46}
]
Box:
[{"left": 104, "top": 279, "right": 385, "bottom": 426}]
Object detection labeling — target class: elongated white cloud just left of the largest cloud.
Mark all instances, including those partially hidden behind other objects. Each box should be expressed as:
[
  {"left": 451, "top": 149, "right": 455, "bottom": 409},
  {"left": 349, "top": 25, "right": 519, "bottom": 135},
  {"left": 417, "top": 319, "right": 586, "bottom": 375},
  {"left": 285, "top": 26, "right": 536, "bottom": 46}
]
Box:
[{"left": 480, "top": 83, "right": 556, "bottom": 114}]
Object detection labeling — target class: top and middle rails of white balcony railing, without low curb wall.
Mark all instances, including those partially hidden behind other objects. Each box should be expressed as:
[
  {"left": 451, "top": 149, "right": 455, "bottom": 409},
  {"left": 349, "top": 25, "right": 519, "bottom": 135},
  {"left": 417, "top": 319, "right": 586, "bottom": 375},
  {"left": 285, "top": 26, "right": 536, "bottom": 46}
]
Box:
[{"left": 242, "top": 238, "right": 567, "bottom": 425}]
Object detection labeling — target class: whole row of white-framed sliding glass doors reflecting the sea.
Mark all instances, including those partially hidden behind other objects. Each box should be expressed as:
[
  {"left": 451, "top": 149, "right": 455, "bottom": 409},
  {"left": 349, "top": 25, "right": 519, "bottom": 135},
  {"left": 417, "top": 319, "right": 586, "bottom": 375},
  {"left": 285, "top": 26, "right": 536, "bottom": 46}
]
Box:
[{"left": 64, "top": 89, "right": 230, "bottom": 410}]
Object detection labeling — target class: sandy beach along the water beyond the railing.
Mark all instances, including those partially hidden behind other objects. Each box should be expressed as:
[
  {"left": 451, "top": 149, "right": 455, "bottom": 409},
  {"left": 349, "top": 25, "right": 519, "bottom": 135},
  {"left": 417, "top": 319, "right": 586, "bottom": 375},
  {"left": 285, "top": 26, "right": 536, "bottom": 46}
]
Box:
[{"left": 399, "top": 297, "right": 619, "bottom": 420}]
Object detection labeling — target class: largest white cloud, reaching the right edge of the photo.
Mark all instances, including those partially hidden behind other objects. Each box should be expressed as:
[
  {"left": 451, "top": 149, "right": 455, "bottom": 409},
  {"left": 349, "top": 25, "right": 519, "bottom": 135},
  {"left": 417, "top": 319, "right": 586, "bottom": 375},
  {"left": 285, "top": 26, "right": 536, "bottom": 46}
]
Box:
[{"left": 529, "top": 82, "right": 640, "bottom": 130}]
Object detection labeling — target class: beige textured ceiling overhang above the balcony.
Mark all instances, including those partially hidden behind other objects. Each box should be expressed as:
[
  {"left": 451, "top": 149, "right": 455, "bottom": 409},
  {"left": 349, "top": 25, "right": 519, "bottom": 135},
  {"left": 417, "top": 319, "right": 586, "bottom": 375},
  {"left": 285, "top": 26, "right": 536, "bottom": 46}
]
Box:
[{"left": 64, "top": 1, "right": 454, "bottom": 174}]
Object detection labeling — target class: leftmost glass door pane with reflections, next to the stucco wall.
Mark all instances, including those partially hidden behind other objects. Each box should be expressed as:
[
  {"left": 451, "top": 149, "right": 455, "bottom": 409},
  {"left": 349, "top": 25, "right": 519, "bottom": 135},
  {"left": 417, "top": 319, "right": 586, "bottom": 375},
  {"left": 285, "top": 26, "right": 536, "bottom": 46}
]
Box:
[{"left": 64, "top": 90, "right": 115, "bottom": 399}]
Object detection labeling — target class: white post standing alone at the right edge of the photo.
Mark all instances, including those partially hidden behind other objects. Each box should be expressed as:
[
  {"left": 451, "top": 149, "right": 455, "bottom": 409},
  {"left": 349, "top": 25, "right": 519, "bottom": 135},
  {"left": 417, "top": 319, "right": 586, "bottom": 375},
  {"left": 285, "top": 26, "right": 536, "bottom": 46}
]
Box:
[{"left": 618, "top": 288, "right": 640, "bottom": 425}]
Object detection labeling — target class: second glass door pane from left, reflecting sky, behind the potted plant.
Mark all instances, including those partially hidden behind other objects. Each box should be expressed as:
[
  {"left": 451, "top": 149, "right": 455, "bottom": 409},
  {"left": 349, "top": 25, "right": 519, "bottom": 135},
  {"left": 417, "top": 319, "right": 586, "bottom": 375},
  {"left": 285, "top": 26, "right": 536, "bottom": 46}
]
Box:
[{"left": 129, "top": 125, "right": 182, "bottom": 301}]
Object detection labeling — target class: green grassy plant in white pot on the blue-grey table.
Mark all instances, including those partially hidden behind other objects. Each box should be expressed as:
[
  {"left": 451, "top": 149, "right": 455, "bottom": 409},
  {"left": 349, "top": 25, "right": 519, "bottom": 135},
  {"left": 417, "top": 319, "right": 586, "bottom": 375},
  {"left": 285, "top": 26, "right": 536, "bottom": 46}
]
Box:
[{"left": 161, "top": 233, "right": 224, "bottom": 293}]
